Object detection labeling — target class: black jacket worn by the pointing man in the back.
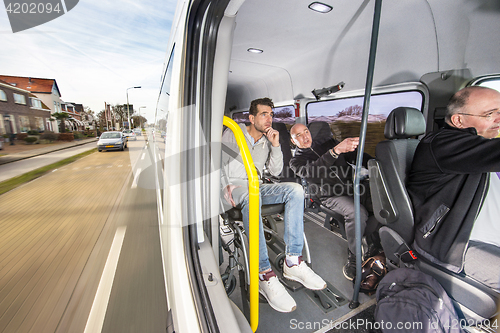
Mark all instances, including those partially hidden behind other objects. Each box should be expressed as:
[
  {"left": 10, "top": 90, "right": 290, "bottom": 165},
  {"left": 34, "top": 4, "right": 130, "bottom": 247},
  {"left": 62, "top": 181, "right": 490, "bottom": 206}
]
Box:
[{"left": 290, "top": 139, "right": 370, "bottom": 198}]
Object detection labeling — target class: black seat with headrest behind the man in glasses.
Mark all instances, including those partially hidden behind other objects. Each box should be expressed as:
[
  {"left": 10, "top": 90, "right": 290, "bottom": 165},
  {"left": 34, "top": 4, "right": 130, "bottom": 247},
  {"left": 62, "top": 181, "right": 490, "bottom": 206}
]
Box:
[{"left": 368, "top": 107, "right": 498, "bottom": 321}]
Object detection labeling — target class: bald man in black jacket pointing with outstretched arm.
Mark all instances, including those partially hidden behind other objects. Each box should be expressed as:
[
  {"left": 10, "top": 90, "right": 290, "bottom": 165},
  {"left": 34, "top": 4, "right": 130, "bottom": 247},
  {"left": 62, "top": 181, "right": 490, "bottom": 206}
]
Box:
[{"left": 290, "top": 124, "right": 379, "bottom": 280}]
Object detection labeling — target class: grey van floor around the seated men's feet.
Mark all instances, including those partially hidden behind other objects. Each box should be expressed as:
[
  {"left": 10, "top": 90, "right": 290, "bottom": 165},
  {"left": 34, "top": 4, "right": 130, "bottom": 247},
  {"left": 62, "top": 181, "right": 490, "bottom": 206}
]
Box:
[{"left": 221, "top": 212, "right": 380, "bottom": 332}]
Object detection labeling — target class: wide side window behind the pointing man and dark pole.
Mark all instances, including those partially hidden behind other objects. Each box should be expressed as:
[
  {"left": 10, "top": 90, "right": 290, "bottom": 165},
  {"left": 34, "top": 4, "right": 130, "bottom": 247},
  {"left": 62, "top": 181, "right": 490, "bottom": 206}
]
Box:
[{"left": 306, "top": 91, "right": 423, "bottom": 156}]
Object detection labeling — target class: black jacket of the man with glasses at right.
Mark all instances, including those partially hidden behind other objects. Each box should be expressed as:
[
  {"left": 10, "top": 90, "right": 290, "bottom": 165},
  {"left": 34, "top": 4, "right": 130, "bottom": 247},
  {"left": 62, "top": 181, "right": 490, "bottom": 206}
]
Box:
[{"left": 407, "top": 125, "right": 500, "bottom": 273}]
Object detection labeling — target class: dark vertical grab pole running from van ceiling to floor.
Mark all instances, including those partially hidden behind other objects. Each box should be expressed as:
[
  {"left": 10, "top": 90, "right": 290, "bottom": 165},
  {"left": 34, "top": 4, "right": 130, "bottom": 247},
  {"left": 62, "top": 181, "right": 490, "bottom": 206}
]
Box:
[{"left": 349, "top": 0, "right": 382, "bottom": 309}]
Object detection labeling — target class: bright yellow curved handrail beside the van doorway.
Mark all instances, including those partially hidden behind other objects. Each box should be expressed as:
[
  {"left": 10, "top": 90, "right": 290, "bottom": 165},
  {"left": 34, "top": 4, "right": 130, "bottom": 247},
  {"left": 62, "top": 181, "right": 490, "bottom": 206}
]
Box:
[{"left": 223, "top": 116, "right": 260, "bottom": 332}]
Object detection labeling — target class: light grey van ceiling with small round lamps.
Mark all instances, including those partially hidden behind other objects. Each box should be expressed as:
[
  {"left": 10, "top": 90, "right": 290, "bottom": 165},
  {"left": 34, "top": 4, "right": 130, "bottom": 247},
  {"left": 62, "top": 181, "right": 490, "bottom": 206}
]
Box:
[{"left": 227, "top": 0, "right": 500, "bottom": 109}]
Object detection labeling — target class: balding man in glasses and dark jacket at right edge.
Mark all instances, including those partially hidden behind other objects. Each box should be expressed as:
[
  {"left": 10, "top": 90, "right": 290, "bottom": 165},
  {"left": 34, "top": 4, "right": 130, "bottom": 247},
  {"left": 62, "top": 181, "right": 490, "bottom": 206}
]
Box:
[{"left": 408, "top": 87, "right": 500, "bottom": 290}]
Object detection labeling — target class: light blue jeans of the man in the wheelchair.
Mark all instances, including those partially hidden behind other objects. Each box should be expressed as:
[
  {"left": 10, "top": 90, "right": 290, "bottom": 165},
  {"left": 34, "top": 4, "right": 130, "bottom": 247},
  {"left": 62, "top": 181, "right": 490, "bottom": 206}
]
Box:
[{"left": 232, "top": 183, "right": 304, "bottom": 272}]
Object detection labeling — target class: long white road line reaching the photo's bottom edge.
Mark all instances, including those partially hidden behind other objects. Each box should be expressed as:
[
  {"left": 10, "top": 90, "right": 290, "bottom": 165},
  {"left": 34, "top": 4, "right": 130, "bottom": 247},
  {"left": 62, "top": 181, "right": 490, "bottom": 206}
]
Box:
[{"left": 84, "top": 226, "right": 127, "bottom": 333}]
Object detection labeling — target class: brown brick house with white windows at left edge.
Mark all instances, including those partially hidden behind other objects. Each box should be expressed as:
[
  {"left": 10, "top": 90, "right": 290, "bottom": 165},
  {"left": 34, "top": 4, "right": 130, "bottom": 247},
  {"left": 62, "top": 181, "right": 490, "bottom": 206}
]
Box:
[{"left": 0, "top": 79, "right": 51, "bottom": 135}]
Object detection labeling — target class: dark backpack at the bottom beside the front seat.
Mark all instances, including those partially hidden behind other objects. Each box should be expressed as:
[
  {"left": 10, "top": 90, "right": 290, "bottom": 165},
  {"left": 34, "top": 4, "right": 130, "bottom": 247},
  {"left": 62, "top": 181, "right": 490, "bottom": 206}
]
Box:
[{"left": 375, "top": 268, "right": 462, "bottom": 332}]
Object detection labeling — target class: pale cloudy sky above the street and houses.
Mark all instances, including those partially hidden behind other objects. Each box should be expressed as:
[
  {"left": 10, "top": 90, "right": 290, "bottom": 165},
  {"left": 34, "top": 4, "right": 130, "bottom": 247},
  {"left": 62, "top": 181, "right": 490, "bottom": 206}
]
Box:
[{"left": 0, "top": 0, "right": 176, "bottom": 121}]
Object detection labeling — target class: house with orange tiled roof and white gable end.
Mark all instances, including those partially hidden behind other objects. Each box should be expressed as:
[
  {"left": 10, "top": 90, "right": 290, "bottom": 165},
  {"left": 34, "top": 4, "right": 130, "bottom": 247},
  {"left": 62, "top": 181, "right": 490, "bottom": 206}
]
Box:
[{"left": 0, "top": 75, "right": 62, "bottom": 132}]
